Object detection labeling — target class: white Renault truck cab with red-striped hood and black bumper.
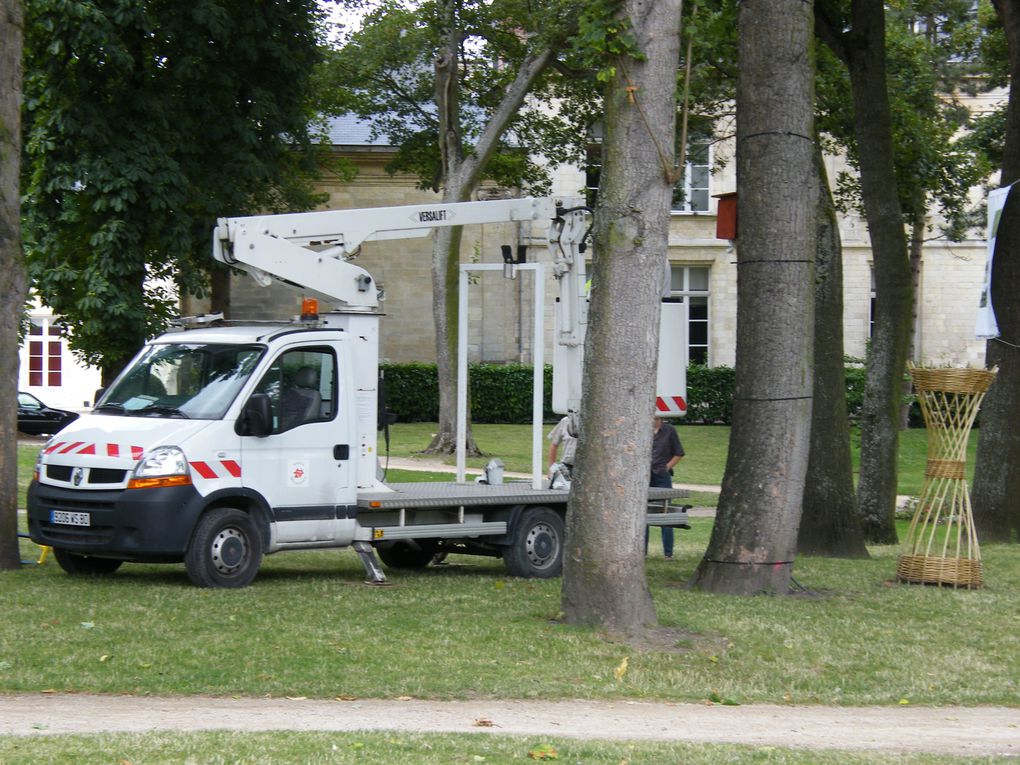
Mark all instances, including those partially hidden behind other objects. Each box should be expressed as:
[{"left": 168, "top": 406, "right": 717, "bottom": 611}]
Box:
[{"left": 29, "top": 325, "right": 373, "bottom": 587}]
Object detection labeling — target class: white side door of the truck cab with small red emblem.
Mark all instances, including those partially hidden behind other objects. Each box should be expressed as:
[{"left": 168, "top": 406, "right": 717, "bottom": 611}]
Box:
[{"left": 241, "top": 346, "right": 356, "bottom": 544}]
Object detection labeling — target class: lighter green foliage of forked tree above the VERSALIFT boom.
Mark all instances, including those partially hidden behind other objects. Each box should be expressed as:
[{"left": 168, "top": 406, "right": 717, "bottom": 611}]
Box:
[{"left": 318, "top": 0, "right": 599, "bottom": 194}]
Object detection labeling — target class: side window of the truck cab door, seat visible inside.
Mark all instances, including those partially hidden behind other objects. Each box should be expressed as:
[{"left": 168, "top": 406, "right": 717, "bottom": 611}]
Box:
[{"left": 255, "top": 348, "right": 337, "bottom": 432}]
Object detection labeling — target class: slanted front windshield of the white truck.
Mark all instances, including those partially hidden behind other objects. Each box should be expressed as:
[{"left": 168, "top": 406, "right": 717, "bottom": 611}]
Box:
[{"left": 95, "top": 343, "right": 265, "bottom": 419}]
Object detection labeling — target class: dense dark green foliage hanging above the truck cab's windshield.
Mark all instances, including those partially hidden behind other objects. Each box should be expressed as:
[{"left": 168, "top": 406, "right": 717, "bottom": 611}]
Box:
[{"left": 22, "top": 0, "right": 320, "bottom": 377}]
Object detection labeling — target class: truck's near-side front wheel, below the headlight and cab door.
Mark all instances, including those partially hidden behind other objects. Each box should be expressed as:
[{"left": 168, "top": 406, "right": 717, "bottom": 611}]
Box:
[{"left": 185, "top": 507, "right": 262, "bottom": 588}]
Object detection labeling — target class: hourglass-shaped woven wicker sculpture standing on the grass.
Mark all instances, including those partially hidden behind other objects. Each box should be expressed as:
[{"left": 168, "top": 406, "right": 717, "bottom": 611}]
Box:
[{"left": 897, "top": 366, "right": 996, "bottom": 588}]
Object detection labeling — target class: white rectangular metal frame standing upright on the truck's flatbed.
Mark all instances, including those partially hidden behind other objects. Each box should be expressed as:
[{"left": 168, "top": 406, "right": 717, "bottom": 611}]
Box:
[{"left": 457, "top": 263, "right": 546, "bottom": 489}]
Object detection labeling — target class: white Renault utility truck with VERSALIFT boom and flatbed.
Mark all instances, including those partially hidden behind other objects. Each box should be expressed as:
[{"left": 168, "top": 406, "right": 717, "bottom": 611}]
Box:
[{"left": 28, "top": 199, "right": 686, "bottom": 588}]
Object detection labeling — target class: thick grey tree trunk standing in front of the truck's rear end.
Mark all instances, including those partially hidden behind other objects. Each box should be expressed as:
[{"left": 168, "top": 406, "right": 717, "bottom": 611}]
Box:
[{"left": 563, "top": 0, "right": 680, "bottom": 634}]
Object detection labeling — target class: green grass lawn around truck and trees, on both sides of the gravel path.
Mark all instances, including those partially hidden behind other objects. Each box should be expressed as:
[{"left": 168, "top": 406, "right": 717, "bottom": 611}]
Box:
[{"left": 9, "top": 425, "right": 1020, "bottom": 765}]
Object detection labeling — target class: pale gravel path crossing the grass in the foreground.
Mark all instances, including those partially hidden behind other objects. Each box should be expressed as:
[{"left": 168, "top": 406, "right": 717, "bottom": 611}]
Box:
[{"left": 0, "top": 694, "right": 1020, "bottom": 757}]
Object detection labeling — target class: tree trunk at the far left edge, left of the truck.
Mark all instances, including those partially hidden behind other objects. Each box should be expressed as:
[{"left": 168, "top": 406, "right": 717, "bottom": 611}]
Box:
[{"left": 0, "top": 0, "right": 28, "bottom": 569}]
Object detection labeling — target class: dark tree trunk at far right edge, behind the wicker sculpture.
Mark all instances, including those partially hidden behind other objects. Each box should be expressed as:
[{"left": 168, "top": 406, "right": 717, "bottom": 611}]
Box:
[{"left": 971, "top": 0, "right": 1020, "bottom": 542}]
